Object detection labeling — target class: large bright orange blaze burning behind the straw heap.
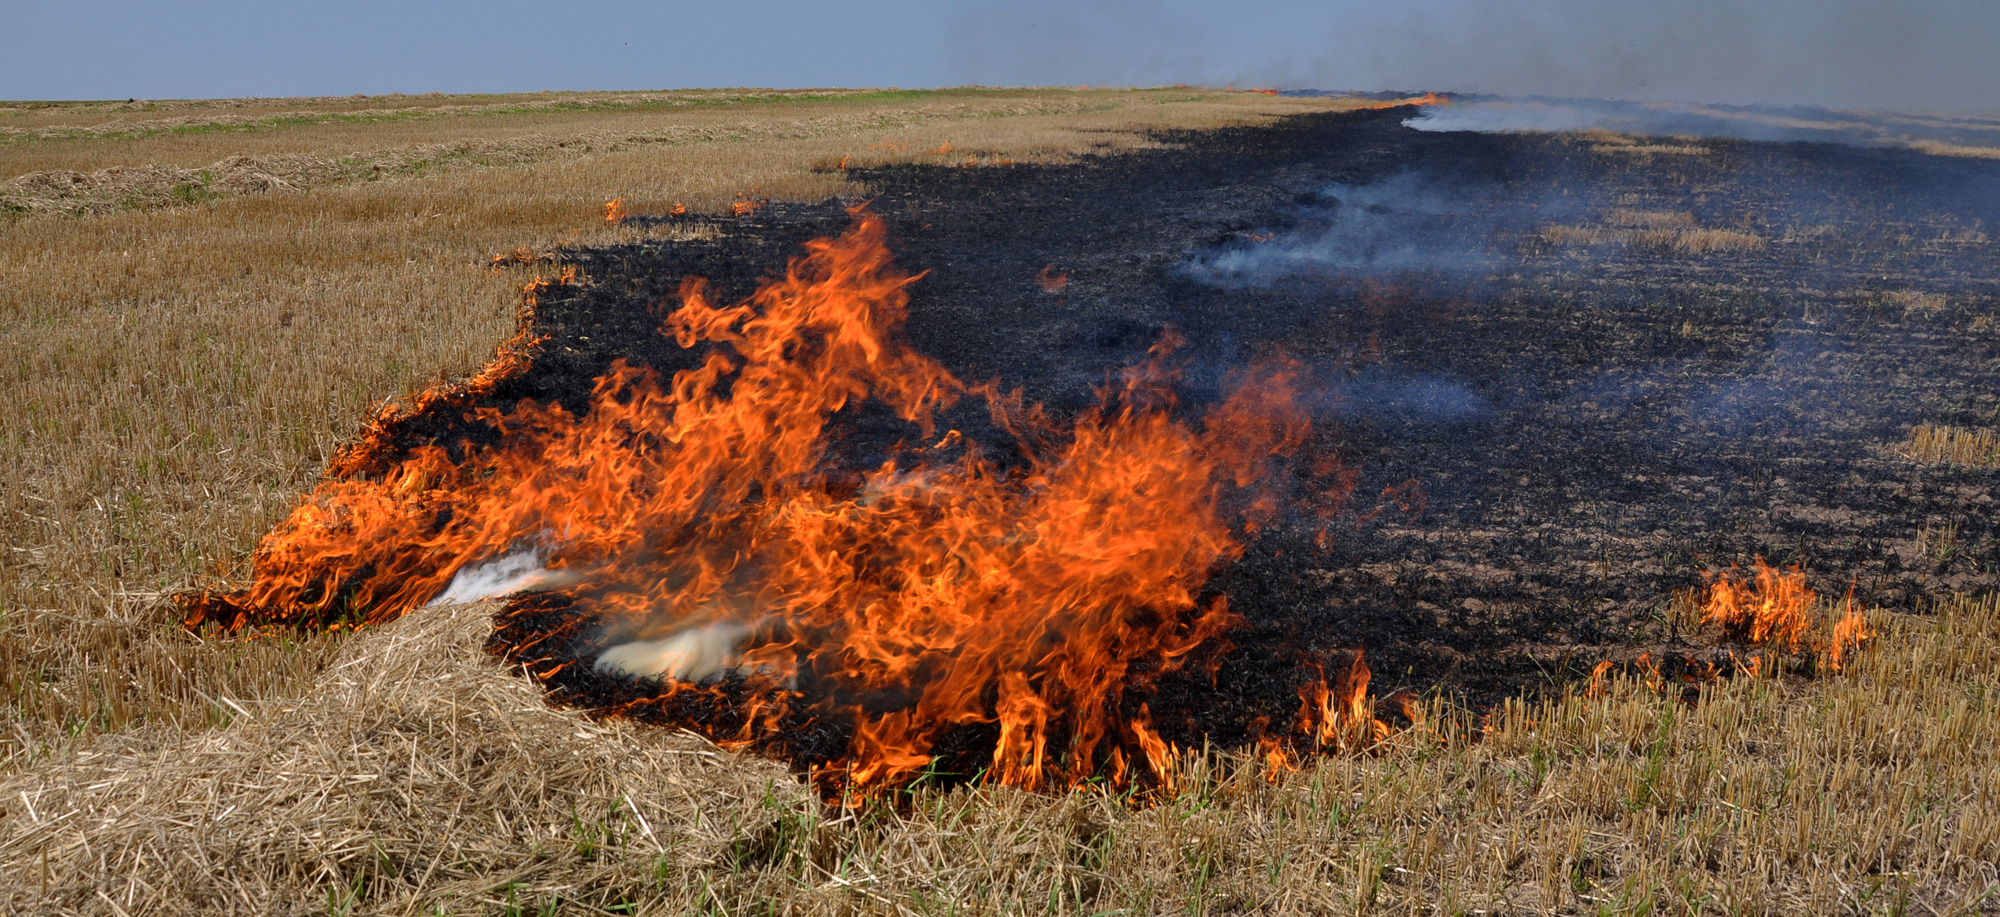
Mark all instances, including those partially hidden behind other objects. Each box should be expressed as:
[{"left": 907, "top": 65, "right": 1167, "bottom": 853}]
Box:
[{"left": 180, "top": 210, "right": 1312, "bottom": 793}]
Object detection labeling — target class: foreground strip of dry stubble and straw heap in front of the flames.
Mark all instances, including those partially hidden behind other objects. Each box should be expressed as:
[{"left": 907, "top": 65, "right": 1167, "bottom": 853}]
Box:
[{"left": 0, "top": 597, "right": 2000, "bottom": 915}]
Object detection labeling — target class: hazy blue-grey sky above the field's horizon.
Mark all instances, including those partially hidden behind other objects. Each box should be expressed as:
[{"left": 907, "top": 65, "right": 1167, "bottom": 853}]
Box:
[{"left": 0, "top": 0, "right": 2000, "bottom": 110}]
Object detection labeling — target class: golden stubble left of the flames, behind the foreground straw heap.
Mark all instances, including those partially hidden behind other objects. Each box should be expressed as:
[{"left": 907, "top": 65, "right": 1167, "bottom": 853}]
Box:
[{"left": 0, "top": 90, "right": 1326, "bottom": 771}]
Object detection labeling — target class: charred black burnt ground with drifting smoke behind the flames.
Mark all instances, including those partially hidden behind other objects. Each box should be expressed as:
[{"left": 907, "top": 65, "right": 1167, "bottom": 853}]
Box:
[{"left": 464, "top": 110, "right": 2000, "bottom": 761}]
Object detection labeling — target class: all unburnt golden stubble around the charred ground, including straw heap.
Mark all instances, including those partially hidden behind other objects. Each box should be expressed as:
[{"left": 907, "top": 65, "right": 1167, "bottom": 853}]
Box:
[{"left": 0, "top": 88, "right": 2000, "bottom": 915}]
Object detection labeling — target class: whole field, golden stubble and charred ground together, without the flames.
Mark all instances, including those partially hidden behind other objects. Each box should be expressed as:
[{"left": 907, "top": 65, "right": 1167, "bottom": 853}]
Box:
[{"left": 0, "top": 90, "right": 2000, "bottom": 913}]
